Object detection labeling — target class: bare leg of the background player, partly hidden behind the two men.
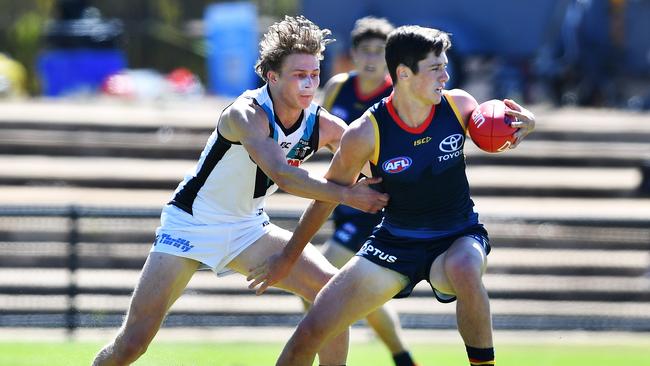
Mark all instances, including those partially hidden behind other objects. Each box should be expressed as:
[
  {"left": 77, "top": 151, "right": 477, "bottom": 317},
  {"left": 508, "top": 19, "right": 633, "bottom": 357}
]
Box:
[{"left": 323, "top": 240, "right": 413, "bottom": 366}]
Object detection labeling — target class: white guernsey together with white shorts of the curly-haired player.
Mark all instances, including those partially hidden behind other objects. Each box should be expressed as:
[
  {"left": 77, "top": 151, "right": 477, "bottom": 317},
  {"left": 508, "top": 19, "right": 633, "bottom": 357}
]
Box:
[{"left": 151, "top": 86, "right": 320, "bottom": 274}]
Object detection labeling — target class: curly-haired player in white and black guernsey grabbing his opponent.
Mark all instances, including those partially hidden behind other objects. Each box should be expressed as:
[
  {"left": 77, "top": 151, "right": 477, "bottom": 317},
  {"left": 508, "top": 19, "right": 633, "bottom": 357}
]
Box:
[{"left": 94, "top": 17, "right": 388, "bottom": 365}]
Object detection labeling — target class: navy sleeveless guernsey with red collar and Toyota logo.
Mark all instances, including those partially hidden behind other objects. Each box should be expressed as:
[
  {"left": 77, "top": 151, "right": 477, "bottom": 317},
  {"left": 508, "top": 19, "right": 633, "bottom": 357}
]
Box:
[{"left": 368, "top": 94, "right": 478, "bottom": 239}]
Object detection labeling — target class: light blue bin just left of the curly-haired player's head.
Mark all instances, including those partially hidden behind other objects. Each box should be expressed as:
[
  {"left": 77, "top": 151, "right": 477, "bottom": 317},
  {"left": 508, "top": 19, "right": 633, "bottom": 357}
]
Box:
[{"left": 204, "top": 2, "right": 258, "bottom": 96}]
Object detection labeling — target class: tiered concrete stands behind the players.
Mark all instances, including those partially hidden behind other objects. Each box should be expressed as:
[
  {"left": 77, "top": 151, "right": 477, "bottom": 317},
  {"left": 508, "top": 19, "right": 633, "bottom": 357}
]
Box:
[{"left": 0, "top": 100, "right": 650, "bottom": 332}]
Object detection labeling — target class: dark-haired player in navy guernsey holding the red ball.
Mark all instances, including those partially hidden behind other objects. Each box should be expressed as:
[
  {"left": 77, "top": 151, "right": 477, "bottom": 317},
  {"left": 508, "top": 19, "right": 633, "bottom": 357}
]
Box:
[{"left": 251, "top": 26, "right": 535, "bottom": 366}]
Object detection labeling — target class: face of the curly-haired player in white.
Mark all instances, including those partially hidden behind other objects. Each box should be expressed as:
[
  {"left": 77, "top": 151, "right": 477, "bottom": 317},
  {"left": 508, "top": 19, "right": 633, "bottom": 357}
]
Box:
[{"left": 276, "top": 53, "right": 320, "bottom": 109}]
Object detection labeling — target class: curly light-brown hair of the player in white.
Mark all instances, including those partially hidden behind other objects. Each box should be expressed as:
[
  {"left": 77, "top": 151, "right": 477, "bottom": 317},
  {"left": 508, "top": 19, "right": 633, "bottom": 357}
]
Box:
[{"left": 255, "top": 15, "right": 334, "bottom": 81}]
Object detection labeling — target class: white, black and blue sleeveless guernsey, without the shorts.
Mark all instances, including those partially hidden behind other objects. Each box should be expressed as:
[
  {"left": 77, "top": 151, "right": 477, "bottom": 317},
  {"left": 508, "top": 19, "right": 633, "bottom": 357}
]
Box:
[{"left": 170, "top": 85, "right": 320, "bottom": 224}]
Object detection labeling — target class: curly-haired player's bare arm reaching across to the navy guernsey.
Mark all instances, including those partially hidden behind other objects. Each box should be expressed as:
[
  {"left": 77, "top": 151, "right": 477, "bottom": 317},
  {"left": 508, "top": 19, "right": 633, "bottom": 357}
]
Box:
[{"left": 219, "top": 98, "right": 388, "bottom": 212}]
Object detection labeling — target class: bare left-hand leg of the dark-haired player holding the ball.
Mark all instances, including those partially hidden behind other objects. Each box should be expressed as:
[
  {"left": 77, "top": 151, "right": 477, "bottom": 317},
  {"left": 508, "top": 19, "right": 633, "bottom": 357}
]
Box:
[{"left": 277, "top": 257, "right": 408, "bottom": 366}]
